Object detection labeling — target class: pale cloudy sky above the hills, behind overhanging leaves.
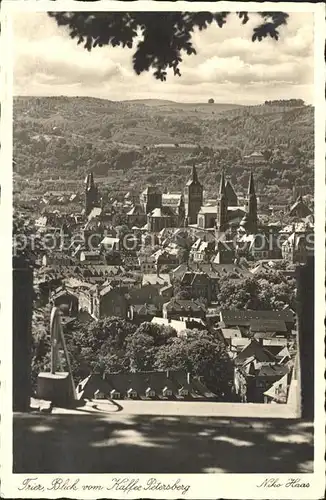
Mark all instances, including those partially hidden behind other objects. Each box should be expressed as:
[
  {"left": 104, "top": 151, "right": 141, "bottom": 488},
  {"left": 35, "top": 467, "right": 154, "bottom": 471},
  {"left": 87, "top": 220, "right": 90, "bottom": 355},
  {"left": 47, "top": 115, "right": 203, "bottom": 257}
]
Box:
[{"left": 14, "top": 12, "right": 314, "bottom": 104}]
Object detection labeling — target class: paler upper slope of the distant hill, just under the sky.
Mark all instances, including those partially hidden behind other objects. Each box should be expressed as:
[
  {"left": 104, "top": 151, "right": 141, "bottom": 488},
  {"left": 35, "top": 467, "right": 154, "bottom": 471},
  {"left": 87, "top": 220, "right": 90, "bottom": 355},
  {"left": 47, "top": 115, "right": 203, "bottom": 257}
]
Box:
[{"left": 14, "top": 97, "right": 313, "bottom": 149}]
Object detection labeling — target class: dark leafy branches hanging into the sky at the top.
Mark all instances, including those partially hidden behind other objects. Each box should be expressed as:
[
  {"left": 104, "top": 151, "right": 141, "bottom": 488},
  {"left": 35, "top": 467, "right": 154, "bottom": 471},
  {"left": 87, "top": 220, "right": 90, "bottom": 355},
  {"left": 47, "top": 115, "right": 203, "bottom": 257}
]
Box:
[{"left": 49, "top": 12, "right": 288, "bottom": 81}]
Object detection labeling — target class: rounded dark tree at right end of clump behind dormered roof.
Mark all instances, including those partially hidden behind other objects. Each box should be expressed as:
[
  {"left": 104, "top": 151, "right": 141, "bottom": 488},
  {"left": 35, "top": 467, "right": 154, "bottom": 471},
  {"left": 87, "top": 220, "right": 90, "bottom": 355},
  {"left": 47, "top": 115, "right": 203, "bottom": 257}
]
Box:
[{"left": 155, "top": 330, "right": 232, "bottom": 400}]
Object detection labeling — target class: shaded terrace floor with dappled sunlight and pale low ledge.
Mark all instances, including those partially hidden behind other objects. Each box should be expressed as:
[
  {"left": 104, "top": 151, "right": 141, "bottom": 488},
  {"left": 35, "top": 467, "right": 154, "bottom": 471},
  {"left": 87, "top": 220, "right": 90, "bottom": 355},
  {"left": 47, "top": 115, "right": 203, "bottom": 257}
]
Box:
[{"left": 13, "top": 401, "right": 314, "bottom": 474}]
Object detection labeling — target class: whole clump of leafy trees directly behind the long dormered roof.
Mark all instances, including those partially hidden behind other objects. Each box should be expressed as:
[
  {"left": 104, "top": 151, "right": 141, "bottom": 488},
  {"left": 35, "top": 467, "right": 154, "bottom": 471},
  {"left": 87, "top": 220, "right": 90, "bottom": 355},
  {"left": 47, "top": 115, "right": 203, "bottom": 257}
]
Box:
[{"left": 32, "top": 317, "right": 232, "bottom": 398}]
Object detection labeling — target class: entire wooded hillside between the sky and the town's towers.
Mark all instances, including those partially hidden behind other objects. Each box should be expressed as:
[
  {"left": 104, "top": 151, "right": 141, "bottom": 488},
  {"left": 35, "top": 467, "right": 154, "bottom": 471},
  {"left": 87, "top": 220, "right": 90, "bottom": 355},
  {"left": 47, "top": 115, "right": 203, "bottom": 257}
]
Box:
[{"left": 14, "top": 97, "right": 314, "bottom": 201}]
